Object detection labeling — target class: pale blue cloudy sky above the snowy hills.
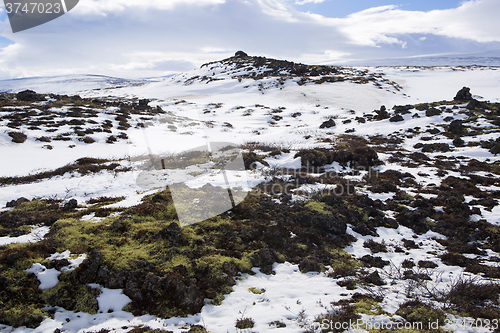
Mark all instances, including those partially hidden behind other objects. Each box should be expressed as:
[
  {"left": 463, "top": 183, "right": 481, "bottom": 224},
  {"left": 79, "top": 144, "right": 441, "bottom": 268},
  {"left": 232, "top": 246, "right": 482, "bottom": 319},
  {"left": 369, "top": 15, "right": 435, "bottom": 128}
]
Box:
[{"left": 0, "top": 0, "right": 500, "bottom": 79}]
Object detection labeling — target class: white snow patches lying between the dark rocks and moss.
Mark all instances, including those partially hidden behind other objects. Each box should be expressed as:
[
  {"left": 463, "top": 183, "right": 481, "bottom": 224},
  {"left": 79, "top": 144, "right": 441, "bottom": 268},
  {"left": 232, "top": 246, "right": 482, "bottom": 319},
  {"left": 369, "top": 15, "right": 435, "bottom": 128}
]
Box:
[{"left": 0, "top": 59, "right": 500, "bottom": 333}]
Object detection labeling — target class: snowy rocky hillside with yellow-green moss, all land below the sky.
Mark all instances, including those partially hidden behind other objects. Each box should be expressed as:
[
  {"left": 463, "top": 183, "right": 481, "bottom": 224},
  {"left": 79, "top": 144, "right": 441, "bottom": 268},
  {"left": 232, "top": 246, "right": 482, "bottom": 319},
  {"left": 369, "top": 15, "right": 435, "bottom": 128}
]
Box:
[{"left": 0, "top": 53, "right": 500, "bottom": 332}]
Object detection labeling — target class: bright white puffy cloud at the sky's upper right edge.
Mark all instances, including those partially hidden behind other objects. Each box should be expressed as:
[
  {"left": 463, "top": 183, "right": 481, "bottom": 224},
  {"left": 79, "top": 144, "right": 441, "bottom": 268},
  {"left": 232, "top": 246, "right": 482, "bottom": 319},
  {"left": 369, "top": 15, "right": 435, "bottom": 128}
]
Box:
[{"left": 332, "top": 0, "right": 500, "bottom": 46}]
